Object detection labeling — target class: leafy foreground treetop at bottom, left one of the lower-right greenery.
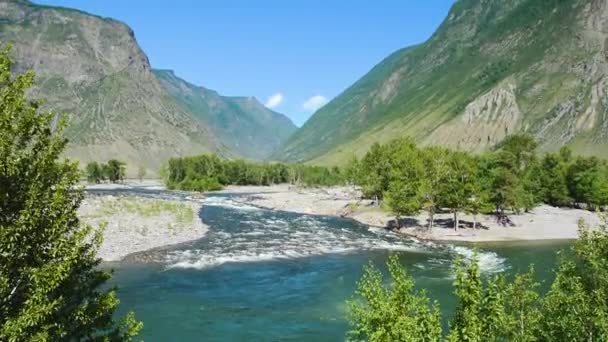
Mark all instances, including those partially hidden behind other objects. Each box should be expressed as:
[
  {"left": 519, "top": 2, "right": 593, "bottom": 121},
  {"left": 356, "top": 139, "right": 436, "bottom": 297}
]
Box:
[{"left": 348, "top": 255, "right": 441, "bottom": 342}]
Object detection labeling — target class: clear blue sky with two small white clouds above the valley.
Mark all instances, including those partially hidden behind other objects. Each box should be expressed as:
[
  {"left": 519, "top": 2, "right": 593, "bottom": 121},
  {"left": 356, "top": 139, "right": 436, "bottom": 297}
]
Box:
[{"left": 36, "top": 0, "right": 454, "bottom": 125}]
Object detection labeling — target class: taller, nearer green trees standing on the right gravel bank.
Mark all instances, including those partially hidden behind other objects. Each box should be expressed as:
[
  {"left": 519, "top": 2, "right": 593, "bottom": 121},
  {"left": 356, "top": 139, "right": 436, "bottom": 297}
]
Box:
[{"left": 344, "top": 134, "right": 608, "bottom": 229}]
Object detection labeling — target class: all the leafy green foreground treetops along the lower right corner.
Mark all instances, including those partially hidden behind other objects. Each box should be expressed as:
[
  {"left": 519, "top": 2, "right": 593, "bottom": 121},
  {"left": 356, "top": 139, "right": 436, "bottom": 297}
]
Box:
[{"left": 348, "top": 218, "right": 608, "bottom": 342}]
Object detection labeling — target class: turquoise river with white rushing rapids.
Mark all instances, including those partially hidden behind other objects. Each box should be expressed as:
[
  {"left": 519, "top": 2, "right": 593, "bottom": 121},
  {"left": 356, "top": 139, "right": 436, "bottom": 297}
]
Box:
[{"left": 97, "top": 192, "right": 567, "bottom": 341}]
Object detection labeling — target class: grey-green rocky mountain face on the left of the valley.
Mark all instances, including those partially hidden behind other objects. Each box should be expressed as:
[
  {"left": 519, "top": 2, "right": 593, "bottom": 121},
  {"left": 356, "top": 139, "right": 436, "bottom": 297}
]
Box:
[{"left": 0, "top": 0, "right": 294, "bottom": 174}]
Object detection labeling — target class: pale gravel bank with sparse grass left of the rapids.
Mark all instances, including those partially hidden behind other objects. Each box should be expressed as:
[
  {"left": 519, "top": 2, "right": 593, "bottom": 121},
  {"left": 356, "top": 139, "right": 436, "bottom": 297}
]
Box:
[{"left": 78, "top": 196, "right": 207, "bottom": 261}]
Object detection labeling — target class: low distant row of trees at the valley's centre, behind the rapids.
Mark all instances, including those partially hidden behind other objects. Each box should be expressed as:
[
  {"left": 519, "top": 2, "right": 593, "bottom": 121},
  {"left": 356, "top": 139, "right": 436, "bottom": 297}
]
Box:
[{"left": 164, "top": 154, "right": 346, "bottom": 191}]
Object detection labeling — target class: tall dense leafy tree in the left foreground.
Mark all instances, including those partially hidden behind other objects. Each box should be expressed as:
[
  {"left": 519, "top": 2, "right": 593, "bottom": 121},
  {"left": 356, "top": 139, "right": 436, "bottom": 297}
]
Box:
[{"left": 0, "top": 49, "right": 141, "bottom": 341}]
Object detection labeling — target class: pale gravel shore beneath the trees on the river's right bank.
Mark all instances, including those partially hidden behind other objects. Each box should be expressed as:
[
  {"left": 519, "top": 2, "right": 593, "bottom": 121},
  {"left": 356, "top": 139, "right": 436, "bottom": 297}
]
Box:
[{"left": 222, "top": 185, "right": 601, "bottom": 242}]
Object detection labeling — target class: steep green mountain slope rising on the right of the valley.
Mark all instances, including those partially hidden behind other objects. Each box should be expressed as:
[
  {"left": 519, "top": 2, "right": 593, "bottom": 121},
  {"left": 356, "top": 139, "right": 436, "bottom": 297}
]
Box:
[{"left": 274, "top": 0, "right": 608, "bottom": 164}]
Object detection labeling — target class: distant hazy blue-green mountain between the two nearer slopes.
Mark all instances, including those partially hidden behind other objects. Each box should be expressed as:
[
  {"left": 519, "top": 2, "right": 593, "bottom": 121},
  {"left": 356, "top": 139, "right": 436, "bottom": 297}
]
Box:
[{"left": 153, "top": 70, "right": 296, "bottom": 160}]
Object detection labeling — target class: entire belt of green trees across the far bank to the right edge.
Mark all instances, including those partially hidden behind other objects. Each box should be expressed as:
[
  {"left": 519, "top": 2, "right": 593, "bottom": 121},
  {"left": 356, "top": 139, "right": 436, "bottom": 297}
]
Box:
[{"left": 166, "top": 134, "right": 608, "bottom": 229}]
